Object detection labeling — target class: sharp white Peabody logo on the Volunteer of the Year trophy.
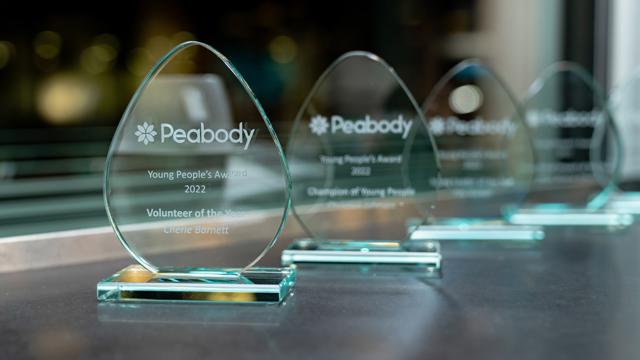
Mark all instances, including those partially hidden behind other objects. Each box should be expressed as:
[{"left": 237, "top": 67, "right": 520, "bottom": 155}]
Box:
[{"left": 134, "top": 121, "right": 256, "bottom": 150}]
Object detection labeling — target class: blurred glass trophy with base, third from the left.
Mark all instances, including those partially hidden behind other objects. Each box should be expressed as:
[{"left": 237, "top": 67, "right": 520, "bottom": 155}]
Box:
[{"left": 412, "top": 60, "right": 544, "bottom": 242}]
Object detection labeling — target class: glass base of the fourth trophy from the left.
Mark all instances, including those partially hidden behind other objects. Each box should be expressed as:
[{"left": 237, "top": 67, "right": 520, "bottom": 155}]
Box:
[{"left": 509, "top": 208, "right": 633, "bottom": 227}]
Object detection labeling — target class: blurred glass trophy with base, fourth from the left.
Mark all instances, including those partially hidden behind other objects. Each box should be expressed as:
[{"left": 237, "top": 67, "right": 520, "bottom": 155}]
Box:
[{"left": 511, "top": 62, "right": 632, "bottom": 227}]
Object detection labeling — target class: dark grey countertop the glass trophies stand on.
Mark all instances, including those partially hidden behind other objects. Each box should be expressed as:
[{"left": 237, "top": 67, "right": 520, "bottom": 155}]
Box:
[{"left": 0, "top": 227, "right": 640, "bottom": 360}]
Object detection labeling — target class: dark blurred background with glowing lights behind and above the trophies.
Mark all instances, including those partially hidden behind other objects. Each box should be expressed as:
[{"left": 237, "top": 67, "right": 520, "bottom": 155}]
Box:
[{"left": 0, "top": 0, "right": 640, "bottom": 236}]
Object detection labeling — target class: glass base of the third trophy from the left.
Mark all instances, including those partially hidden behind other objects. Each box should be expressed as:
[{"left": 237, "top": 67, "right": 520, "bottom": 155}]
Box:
[{"left": 411, "top": 224, "right": 544, "bottom": 241}]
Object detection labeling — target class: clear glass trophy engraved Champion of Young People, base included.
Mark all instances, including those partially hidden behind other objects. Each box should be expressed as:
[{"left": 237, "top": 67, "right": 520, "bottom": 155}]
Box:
[{"left": 282, "top": 51, "right": 440, "bottom": 270}]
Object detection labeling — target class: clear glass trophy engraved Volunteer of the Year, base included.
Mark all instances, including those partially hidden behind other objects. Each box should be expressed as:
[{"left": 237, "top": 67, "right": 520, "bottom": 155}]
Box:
[{"left": 97, "top": 41, "right": 295, "bottom": 303}]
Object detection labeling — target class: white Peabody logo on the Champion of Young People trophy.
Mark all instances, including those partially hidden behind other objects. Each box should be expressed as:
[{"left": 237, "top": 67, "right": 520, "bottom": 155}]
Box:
[{"left": 309, "top": 114, "right": 413, "bottom": 139}]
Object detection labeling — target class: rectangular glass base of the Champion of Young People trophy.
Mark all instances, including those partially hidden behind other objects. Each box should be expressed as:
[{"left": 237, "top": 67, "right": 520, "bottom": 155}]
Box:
[{"left": 281, "top": 239, "right": 442, "bottom": 271}]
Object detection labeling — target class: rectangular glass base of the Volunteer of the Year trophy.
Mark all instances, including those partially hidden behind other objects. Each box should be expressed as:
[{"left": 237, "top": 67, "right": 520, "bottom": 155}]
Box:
[{"left": 97, "top": 265, "right": 296, "bottom": 304}]
